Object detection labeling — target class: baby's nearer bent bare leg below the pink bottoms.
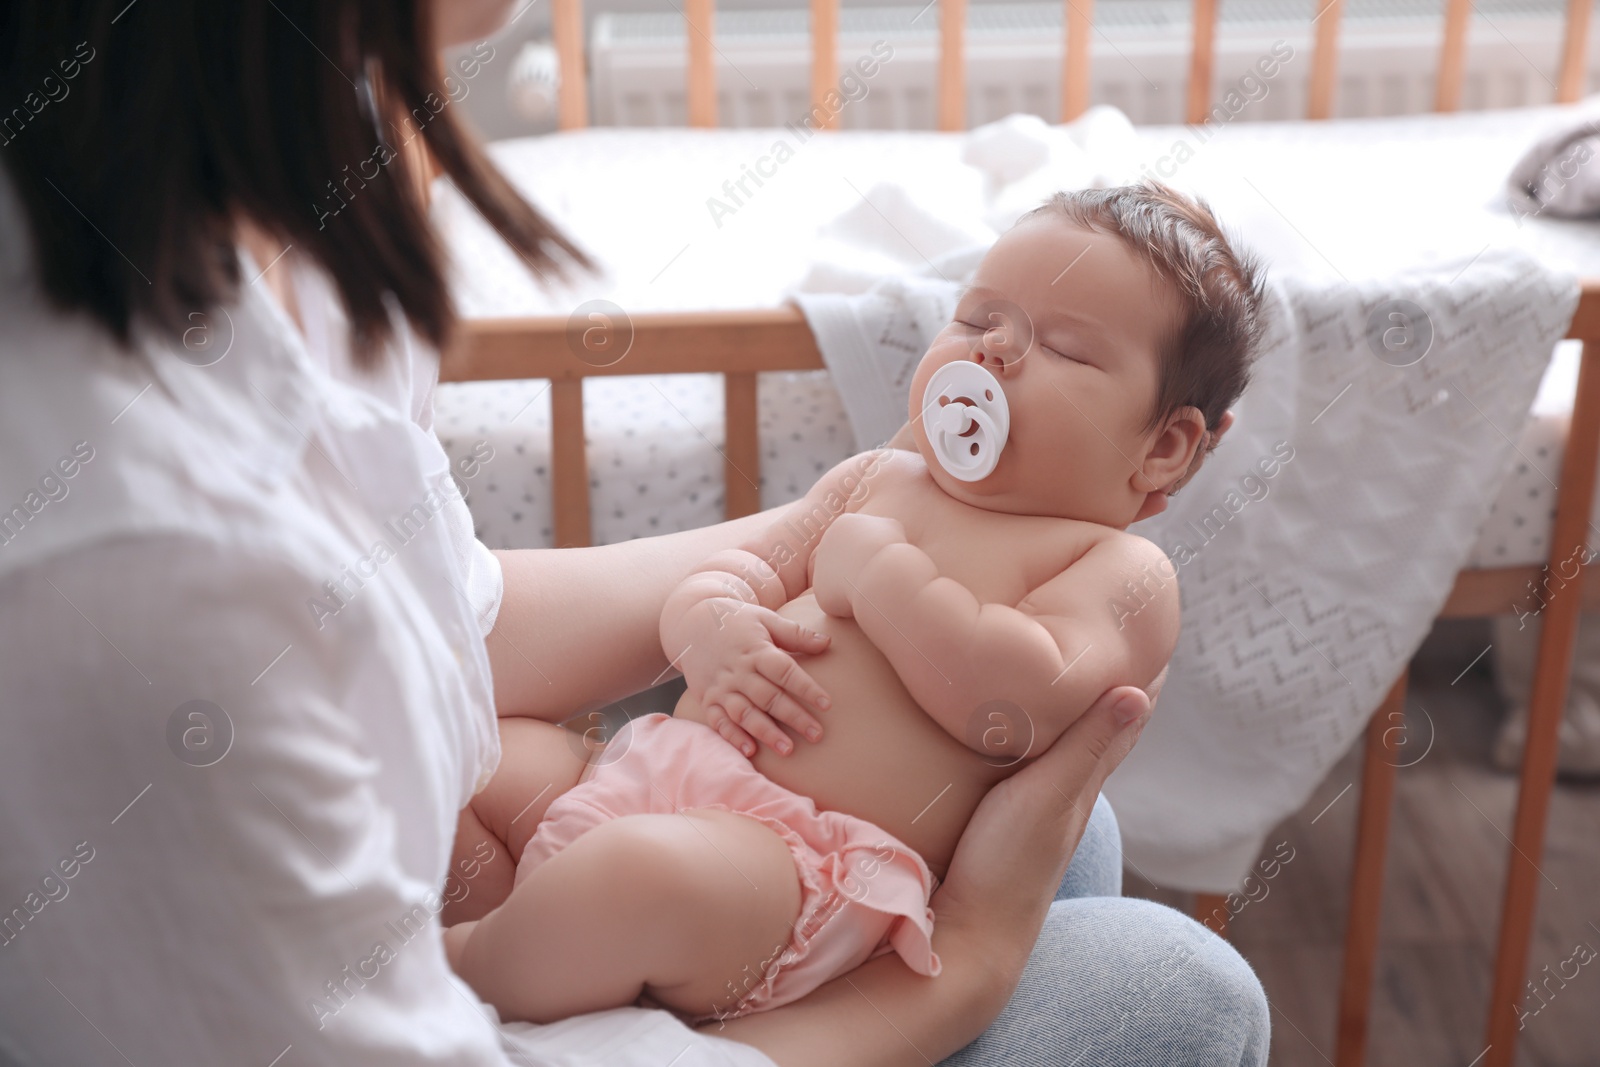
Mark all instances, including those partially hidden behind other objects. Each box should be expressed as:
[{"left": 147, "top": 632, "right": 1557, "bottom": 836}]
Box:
[{"left": 445, "top": 808, "right": 800, "bottom": 1022}]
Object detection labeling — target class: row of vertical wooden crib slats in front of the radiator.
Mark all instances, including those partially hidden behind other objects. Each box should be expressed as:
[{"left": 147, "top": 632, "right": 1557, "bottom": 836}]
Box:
[{"left": 550, "top": 0, "right": 1592, "bottom": 131}]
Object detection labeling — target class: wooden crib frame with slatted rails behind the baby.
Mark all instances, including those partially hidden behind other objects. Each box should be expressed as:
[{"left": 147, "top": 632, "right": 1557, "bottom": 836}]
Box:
[{"left": 442, "top": 0, "right": 1600, "bottom": 1067}]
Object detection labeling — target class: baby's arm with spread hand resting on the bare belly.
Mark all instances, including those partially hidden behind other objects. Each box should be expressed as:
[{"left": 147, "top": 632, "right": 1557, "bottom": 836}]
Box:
[{"left": 661, "top": 453, "right": 883, "bottom": 755}]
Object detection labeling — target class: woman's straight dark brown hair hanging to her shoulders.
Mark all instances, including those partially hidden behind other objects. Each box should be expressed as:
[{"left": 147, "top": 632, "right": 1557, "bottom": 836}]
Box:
[{"left": 0, "top": 0, "right": 589, "bottom": 363}]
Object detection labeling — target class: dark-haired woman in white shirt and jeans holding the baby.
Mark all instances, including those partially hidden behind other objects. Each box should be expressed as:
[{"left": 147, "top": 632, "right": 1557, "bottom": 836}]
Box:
[{"left": 0, "top": 0, "right": 1267, "bottom": 1067}]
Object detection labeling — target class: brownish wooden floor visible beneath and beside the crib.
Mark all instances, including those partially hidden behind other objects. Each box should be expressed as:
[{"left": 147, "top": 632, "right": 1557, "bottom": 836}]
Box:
[{"left": 1126, "top": 622, "right": 1600, "bottom": 1067}]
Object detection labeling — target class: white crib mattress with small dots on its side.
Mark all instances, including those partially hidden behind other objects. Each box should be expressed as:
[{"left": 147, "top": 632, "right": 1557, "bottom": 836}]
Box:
[{"left": 437, "top": 107, "right": 1600, "bottom": 566}]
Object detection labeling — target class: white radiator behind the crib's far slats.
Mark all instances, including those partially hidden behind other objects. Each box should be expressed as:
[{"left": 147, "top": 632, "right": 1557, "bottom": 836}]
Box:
[{"left": 590, "top": 0, "right": 1600, "bottom": 130}]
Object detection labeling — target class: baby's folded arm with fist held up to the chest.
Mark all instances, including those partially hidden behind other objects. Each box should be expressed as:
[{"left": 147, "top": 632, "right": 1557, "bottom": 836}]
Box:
[{"left": 816, "top": 518, "right": 1179, "bottom": 758}]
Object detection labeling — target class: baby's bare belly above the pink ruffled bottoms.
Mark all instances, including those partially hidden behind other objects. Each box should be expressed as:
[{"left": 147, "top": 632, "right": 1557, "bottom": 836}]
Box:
[{"left": 675, "top": 593, "right": 1014, "bottom": 878}]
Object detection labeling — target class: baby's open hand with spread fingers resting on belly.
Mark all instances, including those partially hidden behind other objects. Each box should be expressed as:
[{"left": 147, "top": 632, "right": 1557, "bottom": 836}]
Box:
[{"left": 678, "top": 597, "right": 829, "bottom": 757}]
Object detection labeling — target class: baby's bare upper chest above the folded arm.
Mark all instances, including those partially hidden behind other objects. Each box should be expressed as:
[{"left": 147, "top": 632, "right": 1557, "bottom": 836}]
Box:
[{"left": 859, "top": 463, "right": 1107, "bottom": 605}]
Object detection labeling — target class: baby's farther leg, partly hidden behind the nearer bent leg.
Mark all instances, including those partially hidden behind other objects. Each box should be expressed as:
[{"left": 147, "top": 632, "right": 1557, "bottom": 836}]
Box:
[{"left": 440, "top": 718, "right": 586, "bottom": 926}]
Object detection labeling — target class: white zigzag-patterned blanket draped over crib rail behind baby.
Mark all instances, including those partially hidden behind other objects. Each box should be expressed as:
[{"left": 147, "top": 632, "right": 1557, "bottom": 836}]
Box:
[{"left": 797, "top": 115, "right": 1578, "bottom": 893}]
